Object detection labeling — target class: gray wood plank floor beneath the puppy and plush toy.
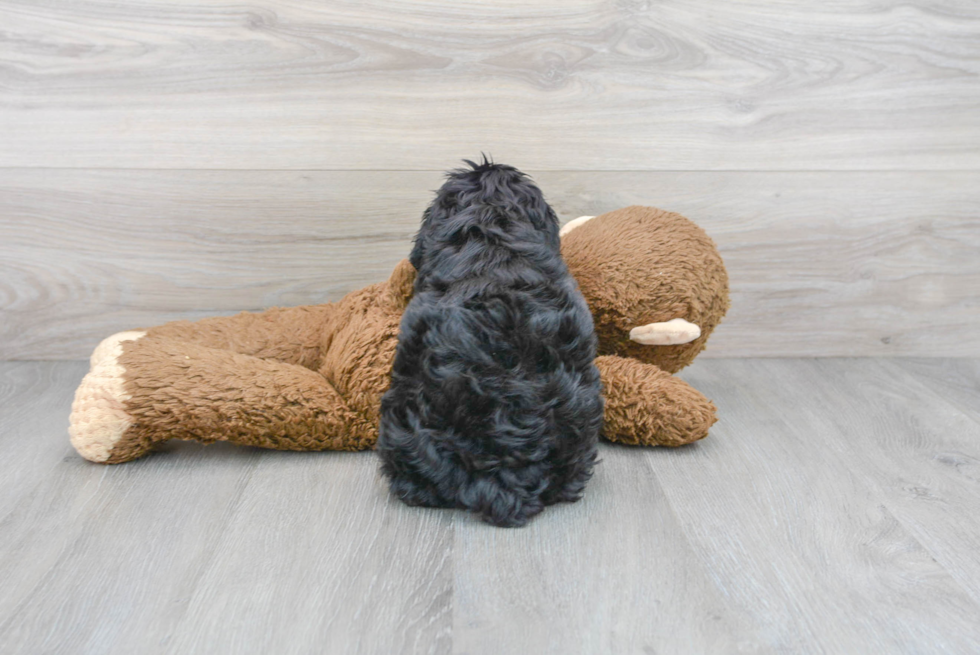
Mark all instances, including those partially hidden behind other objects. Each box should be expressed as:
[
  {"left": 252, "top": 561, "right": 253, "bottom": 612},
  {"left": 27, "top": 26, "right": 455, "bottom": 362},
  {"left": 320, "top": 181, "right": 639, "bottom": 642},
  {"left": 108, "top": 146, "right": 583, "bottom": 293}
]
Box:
[{"left": 0, "top": 359, "right": 980, "bottom": 654}]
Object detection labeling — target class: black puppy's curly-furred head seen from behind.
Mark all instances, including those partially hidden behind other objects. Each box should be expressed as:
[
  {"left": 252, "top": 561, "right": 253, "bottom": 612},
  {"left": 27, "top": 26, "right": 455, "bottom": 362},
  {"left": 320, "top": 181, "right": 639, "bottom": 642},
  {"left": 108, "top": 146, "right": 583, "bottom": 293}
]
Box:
[{"left": 409, "top": 157, "right": 560, "bottom": 275}]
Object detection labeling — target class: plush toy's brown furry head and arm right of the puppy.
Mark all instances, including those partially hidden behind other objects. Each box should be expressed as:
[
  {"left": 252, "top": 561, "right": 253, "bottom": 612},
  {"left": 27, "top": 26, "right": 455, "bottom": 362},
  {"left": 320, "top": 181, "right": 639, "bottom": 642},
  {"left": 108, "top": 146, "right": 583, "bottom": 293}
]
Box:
[{"left": 562, "top": 206, "right": 729, "bottom": 446}]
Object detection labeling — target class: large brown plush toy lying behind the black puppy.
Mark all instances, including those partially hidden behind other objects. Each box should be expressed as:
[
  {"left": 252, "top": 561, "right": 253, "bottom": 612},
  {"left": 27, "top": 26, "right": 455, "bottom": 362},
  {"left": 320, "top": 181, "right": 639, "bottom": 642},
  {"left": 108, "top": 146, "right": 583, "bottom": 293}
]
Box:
[{"left": 69, "top": 207, "right": 728, "bottom": 464}]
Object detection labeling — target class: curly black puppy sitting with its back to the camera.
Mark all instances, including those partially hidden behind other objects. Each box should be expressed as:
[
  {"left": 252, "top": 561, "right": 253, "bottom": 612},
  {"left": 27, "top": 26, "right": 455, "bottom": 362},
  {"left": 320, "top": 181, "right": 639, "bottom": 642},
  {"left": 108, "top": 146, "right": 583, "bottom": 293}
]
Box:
[{"left": 378, "top": 159, "right": 603, "bottom": 526}]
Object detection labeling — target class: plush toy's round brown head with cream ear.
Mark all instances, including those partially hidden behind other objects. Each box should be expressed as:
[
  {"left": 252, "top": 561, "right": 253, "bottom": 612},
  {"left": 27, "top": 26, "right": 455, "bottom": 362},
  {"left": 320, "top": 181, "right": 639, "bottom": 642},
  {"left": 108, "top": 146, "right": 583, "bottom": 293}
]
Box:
[{"left": 562, "top": 206, "right": 728, "bottom": 373}]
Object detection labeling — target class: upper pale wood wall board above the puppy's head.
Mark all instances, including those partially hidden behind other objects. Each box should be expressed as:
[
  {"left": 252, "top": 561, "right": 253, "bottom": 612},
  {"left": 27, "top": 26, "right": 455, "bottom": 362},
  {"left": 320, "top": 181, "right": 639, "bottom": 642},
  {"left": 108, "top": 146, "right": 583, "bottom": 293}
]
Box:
[{"left": 0, "top": 0, "right": 980, "bottom": 170}]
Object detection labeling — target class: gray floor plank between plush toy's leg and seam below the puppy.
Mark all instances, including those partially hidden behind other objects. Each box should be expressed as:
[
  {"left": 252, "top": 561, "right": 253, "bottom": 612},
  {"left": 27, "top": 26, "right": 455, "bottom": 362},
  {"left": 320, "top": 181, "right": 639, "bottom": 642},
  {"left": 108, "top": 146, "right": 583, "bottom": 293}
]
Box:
[{"left": 160, "top": 453, "right": 453, "bottom": 654}]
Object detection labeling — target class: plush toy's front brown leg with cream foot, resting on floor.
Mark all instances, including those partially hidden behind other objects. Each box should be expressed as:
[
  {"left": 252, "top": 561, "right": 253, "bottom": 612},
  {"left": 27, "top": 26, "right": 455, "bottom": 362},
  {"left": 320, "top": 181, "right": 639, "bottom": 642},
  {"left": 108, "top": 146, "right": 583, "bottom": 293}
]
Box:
[{"left": 69, "top": 332, "right": 377, "bottom": 464}]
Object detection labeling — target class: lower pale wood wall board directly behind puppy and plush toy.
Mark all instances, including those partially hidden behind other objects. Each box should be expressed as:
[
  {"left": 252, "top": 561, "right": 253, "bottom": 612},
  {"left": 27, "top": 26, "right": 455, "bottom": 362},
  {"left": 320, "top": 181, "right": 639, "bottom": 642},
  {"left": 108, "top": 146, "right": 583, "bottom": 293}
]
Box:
[{"left": 0, "top": 169, "right": 980, "bottom": 359}]
